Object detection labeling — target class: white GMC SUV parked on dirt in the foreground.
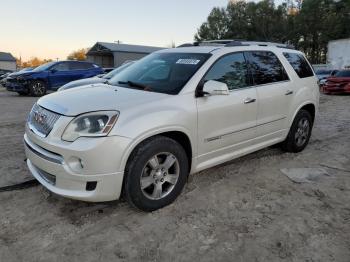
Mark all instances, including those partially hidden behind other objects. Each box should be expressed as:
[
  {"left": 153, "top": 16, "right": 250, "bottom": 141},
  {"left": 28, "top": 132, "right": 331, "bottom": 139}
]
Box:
[{"left": 24, "top": 41, "right": 319, "bottom": 211}]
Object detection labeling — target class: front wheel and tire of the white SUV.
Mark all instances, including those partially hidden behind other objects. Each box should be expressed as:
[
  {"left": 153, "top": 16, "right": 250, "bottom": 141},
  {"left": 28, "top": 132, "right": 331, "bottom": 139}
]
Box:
[{"left": 124, "top": 136, "right": 189, "bottom": 212}]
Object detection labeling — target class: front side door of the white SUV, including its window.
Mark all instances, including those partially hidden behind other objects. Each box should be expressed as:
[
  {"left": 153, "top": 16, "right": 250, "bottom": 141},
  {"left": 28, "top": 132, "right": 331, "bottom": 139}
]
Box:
[{"left": 197, "top": 52, "right": 258, "bottom": 168}]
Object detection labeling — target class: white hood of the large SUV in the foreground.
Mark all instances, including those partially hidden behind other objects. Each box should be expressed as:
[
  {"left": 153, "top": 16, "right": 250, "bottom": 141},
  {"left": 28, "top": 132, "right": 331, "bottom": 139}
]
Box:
[{"left": 37, "top": 84, "right": 169, "bottom": 116}]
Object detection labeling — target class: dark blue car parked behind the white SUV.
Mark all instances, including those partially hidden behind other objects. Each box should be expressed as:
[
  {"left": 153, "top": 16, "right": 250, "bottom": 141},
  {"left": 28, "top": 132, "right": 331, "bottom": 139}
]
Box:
[{"left": 5, "top": 61, "right": 103, "bottom": 96}]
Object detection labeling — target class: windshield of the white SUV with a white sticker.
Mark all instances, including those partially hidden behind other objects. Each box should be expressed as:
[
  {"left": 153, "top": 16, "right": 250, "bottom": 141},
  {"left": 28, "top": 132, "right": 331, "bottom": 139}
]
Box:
[{"left": 109, "top": 53, "right": 211, "bottom": 94}]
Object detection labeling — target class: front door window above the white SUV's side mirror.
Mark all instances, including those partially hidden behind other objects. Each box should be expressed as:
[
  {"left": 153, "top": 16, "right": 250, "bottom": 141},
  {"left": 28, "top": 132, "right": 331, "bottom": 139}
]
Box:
[{"left": 204, "top": 53, "right": 249, "bottom": 90}]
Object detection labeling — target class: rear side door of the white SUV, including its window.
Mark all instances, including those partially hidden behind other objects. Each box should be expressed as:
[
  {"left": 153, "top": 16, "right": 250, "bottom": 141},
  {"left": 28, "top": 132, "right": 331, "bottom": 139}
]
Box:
[{"left": 245, "top": 51, "right": 294, "bottom": 138}]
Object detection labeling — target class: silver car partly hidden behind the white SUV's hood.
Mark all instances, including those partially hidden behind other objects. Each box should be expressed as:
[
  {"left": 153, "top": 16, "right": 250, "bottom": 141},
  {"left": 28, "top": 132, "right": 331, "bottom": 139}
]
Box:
[{"left": 57, "top": 61, "right": 135, "bottom": 91}]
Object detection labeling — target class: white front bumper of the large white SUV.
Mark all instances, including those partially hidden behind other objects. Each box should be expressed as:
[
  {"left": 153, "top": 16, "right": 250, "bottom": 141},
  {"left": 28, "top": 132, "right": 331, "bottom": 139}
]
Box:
[{"left": 24, "top": 125, "right": 130, "bottom": 202}]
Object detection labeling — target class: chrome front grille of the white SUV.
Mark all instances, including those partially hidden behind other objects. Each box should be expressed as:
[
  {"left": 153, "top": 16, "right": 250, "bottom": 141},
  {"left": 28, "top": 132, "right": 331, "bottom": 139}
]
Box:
[{"left": 28, "top": 104, "right": 61, "bottom": 137}]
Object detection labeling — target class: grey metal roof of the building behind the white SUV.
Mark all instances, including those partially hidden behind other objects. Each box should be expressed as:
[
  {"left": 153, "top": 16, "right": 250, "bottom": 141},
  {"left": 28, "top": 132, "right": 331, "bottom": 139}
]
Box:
[{"left": 87, "top": 42, "right": 164, "bottom": 55}]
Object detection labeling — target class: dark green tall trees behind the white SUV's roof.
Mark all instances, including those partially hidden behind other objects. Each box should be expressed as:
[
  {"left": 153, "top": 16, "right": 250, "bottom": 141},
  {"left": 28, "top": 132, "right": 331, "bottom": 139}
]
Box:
[{"left": 194, "top": 0, "right": 350, "bottom": 63}]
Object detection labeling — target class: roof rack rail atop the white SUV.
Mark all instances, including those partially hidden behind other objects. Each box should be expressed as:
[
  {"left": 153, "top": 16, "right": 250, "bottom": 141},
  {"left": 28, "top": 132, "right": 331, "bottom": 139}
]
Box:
[{"left": 178, "top": 39, "right": 295, "bottom": 49}]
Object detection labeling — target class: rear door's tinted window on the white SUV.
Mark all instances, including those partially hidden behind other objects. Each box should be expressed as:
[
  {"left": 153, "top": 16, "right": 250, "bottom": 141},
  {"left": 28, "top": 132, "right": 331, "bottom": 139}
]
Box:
[{"left": 247, "top": 51, "right": 289, "bottom": 85}]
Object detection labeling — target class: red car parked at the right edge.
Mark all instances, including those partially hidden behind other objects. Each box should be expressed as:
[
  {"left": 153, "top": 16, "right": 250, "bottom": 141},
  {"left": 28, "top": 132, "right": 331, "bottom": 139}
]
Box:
[{"left": 322, "top": 69, "right": 350, "bottom": 94}]
